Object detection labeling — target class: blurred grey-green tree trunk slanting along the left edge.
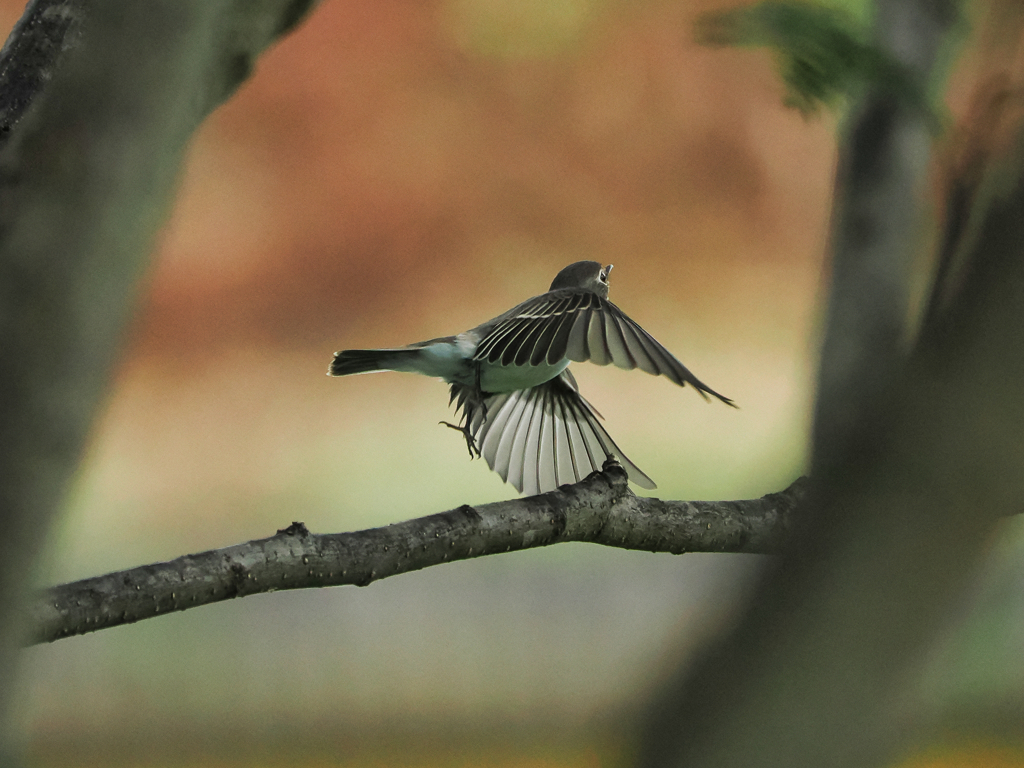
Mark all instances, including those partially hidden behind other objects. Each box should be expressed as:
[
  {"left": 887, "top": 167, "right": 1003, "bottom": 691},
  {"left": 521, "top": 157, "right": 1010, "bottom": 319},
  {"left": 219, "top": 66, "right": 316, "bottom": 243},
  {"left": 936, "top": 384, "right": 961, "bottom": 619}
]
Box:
[{"left": 0, "top": 0, "right": 313, "bottom": 765}]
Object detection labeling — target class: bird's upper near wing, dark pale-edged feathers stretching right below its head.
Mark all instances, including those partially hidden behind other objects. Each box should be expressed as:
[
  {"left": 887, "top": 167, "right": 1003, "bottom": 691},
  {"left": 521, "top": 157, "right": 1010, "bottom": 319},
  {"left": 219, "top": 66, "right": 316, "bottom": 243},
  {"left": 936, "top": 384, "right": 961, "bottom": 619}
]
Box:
[{"left": 474, "top": 290, "right": 733, "bottom": 406}]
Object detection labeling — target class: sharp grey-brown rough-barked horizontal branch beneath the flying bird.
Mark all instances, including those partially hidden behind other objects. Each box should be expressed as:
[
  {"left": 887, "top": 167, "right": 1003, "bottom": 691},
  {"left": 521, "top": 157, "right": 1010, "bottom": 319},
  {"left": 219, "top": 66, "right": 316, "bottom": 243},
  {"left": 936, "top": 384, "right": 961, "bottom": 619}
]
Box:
[{"left": 29, "top": 463, "right": 804, "bottom": 642}]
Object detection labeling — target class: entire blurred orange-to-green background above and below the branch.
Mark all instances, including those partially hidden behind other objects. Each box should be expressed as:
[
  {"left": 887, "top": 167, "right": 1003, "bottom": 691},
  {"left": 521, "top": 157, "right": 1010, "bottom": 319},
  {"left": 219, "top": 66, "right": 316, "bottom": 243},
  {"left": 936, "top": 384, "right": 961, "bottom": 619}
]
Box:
[{"left": 8, "top": 0, "right": 1024, "bottom": 766}]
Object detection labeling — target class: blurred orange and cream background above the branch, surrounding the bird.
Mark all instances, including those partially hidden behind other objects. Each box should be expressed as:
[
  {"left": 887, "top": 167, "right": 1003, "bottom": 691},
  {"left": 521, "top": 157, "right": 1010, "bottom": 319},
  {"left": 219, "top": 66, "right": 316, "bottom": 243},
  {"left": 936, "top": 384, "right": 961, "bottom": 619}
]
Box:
[{"left": 34, "top": 0, "right": 835, "bottom": 579}]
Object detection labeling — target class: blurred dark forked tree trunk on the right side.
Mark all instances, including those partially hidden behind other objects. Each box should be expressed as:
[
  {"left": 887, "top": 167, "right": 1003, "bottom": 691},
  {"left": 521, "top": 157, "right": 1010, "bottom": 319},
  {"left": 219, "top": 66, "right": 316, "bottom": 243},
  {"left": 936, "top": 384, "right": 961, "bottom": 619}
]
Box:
[{"left": 640, "top": 0, "right": 1024, "bottom": 768}]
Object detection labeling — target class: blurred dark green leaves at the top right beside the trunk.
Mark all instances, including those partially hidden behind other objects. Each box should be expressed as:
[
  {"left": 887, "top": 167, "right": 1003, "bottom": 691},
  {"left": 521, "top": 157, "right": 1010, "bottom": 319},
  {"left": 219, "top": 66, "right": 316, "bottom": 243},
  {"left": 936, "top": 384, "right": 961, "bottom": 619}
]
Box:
[{"left": 696, "top": 0, "right": 937, "bottom": 123}]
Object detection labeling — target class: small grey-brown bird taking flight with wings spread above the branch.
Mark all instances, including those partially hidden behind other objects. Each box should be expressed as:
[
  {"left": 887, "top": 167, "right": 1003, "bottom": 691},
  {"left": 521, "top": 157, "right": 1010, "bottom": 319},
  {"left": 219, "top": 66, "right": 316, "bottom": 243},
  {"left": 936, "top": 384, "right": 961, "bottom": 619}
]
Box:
[{"left": 328, "top": 261, "right": 736, "bottom": 496}]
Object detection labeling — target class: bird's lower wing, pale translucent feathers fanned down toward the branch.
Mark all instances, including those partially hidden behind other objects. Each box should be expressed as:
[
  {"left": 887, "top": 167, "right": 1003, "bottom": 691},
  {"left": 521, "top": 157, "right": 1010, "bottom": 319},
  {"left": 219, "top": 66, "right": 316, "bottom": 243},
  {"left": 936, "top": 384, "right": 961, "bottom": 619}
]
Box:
[{"left": 452, "top": 371, "right": 656, "bottom": 496}]
